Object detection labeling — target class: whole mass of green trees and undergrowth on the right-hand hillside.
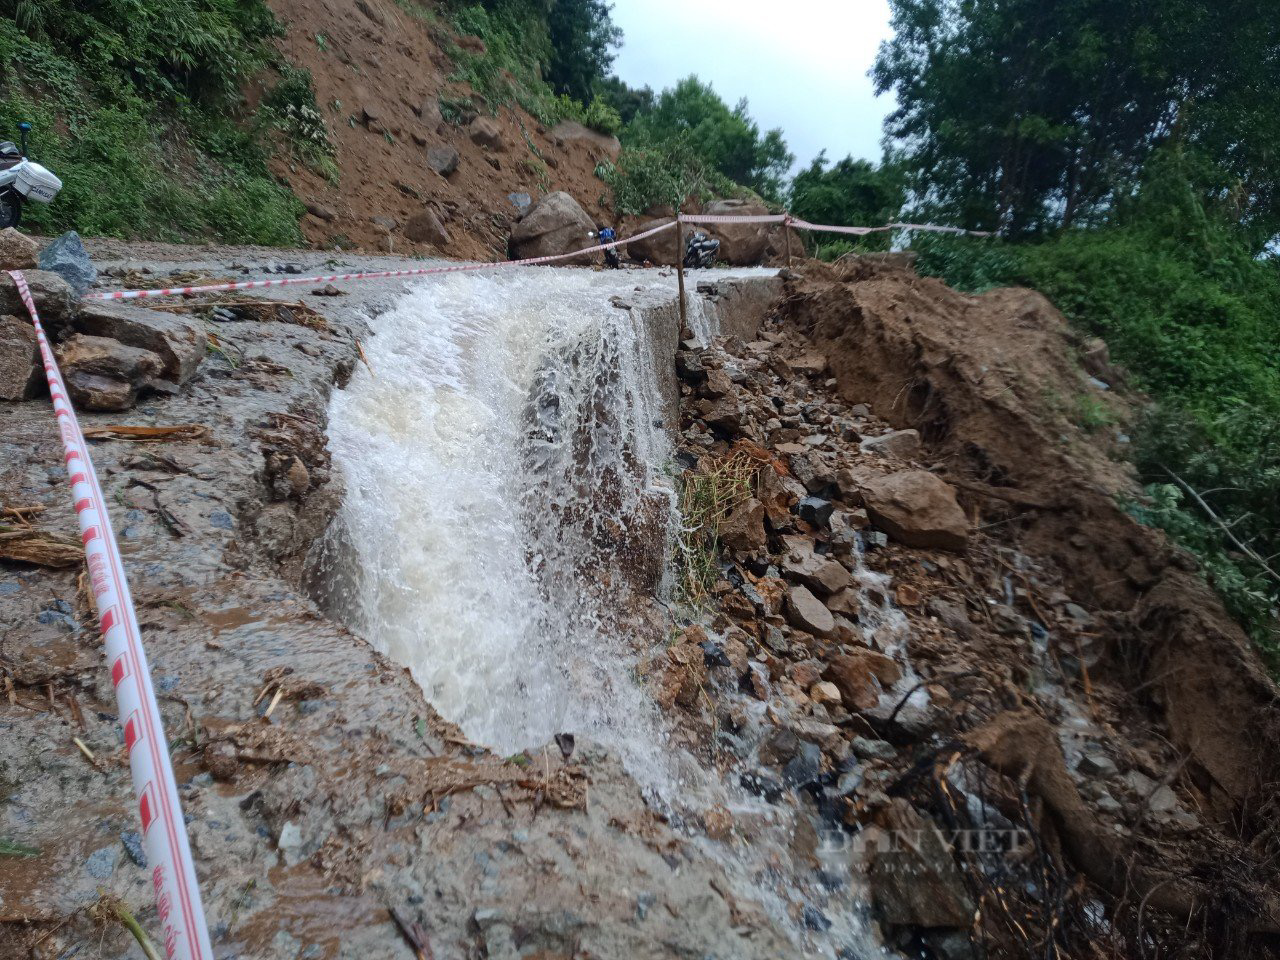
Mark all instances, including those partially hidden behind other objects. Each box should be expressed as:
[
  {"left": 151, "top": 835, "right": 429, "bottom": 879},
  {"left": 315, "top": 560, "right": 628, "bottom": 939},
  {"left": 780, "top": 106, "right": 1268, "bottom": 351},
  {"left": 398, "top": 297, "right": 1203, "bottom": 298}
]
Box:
[{"left": 876, "top": 0, "right": 1280, "bottom": 668}]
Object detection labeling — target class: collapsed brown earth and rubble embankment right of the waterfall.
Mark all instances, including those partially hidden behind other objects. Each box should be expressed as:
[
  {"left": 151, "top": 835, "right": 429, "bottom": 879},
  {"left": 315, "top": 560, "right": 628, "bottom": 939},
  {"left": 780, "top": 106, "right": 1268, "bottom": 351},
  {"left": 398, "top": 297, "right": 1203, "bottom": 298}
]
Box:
[{"left": 659, "top": 257, "right": 1280, "bottom": 957}]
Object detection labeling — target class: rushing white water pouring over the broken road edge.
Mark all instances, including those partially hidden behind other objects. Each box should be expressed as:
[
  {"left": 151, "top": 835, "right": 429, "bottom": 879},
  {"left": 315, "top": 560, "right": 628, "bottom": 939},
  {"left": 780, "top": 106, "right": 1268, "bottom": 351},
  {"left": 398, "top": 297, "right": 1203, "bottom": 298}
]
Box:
[{"left": 329, "top": 269, "right": 757, "bottom": 780}]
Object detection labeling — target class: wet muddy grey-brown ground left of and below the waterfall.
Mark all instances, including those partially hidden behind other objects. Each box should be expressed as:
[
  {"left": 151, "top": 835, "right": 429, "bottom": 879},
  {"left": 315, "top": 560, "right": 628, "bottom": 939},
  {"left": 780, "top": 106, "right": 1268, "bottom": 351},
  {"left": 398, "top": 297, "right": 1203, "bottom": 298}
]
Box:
[{"left": 0, "top": 243, "right": 790, "bottom": 959}]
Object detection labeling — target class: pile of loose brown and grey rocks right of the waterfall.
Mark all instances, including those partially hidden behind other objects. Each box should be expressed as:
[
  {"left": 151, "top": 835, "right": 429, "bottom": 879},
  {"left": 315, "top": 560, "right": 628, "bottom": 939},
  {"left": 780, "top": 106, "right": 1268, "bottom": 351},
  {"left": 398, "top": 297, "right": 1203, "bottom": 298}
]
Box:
[{"left": 650, "top": 305, "right": 1223, "bottom": 957}]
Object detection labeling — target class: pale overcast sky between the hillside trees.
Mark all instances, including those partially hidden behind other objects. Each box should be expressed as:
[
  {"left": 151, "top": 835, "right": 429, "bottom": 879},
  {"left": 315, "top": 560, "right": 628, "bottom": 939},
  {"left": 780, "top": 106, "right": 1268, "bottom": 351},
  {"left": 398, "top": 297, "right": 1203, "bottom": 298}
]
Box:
[{"left": 613, "top": 0, "right": 893, "bottom": 165}]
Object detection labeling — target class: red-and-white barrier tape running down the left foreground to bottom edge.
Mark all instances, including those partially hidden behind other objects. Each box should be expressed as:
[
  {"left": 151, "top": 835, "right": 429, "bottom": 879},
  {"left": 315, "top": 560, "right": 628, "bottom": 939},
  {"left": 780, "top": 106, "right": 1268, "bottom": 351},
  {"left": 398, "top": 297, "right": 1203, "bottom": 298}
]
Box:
[{"left": 9, "top": 270, "right": 214, "bottom": 960}]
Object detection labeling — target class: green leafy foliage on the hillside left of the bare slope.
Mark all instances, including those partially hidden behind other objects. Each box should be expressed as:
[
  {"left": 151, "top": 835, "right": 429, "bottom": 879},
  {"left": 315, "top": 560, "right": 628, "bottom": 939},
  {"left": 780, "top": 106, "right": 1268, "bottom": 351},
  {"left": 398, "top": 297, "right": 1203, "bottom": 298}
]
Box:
[{"left": 0, "top": 6, "right": 302, "bottom": 244}]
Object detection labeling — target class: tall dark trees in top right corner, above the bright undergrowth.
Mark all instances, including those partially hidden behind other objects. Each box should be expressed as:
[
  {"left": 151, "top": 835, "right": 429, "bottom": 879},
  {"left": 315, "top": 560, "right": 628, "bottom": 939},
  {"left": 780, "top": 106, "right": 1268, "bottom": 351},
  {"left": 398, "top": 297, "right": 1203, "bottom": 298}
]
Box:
[{"left": 873, "top": 0, "right": 1280, "bottom": 244}]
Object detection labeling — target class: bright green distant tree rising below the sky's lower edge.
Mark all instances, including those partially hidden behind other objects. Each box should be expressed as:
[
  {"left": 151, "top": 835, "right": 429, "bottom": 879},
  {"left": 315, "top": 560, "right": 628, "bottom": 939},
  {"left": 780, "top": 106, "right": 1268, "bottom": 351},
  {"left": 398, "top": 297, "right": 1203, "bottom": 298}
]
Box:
[{"left": 630, "top": 76, "right": 795, "bottom": 200}]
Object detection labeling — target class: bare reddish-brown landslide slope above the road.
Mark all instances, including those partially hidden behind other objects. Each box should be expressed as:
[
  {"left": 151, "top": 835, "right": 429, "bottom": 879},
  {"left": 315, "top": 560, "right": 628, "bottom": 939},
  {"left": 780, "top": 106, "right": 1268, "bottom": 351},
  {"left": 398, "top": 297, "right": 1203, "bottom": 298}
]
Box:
[{"left": 269, "top": 0, "right": 617, "bottom": 260}]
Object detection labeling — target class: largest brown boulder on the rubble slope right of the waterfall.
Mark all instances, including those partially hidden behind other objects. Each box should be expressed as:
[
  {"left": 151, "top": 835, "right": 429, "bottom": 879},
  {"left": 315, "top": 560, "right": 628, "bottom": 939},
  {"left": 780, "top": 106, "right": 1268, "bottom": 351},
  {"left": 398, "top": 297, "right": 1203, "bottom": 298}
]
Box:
[{"left": 863, "top": 470, "right": 969, "bottom": 552}]
